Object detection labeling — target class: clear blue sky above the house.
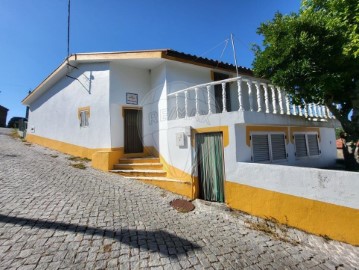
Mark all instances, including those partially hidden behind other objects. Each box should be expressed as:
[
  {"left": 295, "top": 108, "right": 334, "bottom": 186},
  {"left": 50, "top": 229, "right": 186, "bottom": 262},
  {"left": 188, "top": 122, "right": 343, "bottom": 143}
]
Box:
[{"left": 0, "top": 0, "right": 300, "bottom": 120}]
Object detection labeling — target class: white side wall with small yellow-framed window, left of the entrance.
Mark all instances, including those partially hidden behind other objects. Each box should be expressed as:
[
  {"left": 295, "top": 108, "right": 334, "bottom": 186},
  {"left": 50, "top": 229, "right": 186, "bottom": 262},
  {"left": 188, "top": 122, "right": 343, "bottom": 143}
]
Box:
[{"left": 27, "top": 63, "right": 111, "bottom": 148}]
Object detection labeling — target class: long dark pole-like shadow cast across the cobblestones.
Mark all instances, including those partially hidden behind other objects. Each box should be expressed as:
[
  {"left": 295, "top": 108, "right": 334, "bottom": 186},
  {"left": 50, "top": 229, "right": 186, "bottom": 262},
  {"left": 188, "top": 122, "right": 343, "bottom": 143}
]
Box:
[{"left": 0, "top": 214, "right": 200, "bottom": 257}]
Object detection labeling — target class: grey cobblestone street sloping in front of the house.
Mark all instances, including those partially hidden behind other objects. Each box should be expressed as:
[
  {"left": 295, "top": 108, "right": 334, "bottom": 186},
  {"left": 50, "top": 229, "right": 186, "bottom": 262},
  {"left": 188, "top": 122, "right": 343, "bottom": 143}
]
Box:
[{"left": 0, "top": 129, "right": 359, "bottom": 269}]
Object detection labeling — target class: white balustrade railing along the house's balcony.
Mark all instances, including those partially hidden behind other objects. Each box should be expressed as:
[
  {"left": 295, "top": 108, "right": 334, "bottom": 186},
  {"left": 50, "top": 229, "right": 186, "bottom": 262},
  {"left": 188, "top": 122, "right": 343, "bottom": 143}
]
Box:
[{"left": 168, "top": 76, "right": 334, "bottom": 121}]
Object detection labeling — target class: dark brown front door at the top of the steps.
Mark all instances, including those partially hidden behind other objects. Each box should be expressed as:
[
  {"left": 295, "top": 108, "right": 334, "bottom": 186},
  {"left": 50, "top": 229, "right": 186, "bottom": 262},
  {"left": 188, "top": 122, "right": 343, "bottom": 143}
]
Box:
[{"left": 124, "top": 109, "right": 143, "bottom": 153}]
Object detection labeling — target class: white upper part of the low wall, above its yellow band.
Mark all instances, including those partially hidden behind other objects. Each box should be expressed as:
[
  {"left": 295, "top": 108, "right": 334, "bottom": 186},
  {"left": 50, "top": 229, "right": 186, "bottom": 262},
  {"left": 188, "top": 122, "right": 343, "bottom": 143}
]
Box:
[{"left": 229, "top": 162, "right": 359, "bottom": 209}]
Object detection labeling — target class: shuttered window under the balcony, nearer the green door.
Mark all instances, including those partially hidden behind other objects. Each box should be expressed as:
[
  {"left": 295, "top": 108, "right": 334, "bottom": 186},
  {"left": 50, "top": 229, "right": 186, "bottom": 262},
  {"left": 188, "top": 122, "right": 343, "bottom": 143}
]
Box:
[{"left": 250, "top": 133, "right": 287, "bottom": 162}]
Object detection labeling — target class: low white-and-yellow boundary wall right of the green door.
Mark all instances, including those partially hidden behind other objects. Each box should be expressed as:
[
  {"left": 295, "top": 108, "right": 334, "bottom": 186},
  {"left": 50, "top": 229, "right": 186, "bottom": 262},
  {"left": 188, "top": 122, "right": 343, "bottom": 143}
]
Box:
[{"left": 225, "top": 163, "right": 359, "bottom": 245}]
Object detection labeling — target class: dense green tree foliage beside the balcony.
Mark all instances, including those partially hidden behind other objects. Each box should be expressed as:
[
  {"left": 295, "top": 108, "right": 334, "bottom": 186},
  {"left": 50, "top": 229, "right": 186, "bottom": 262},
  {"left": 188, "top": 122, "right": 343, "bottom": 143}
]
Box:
[{"left": 253, "top": 0, "right": 359, "bottom": 138}]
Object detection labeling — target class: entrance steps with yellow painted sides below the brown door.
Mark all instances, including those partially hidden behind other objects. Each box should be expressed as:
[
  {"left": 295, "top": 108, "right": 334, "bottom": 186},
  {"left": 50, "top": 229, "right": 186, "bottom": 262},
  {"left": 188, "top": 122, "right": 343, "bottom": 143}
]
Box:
[{"left": 110, "top": 156, "right": 192, "bottom": 197}]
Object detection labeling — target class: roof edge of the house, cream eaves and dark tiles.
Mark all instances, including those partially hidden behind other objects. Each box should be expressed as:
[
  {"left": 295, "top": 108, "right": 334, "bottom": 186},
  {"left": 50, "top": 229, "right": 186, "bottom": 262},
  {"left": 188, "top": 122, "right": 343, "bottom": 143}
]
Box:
[{"left": 22, "top": 49, "right": 253, "bottom": 105}]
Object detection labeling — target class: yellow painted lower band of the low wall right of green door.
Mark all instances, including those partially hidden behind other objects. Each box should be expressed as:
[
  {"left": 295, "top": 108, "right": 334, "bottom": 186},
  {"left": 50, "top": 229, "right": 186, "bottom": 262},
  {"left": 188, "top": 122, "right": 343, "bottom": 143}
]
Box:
[{"left": 225, "top": 181, "right": 359, "bottom": 245}]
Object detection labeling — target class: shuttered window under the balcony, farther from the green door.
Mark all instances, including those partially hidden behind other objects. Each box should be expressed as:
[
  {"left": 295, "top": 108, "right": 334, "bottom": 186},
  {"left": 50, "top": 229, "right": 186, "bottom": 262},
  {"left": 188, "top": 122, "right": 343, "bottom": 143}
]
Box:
[{"left": 294, "top": 133, "right": 321, "bottom": 158}]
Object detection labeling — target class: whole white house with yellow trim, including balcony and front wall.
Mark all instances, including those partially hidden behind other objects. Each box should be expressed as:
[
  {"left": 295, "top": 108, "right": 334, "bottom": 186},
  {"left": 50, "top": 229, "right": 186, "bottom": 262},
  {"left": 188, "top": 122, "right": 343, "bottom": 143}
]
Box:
[{"left": 23, "top": 49, "right": 359, "bottom": 245}]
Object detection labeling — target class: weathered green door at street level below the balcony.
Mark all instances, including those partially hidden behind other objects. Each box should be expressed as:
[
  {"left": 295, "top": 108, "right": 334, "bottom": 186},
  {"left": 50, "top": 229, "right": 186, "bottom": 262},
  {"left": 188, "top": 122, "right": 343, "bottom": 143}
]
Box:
[{"left": 196, "top": 132, "right": 224, "bottom": 202}]
